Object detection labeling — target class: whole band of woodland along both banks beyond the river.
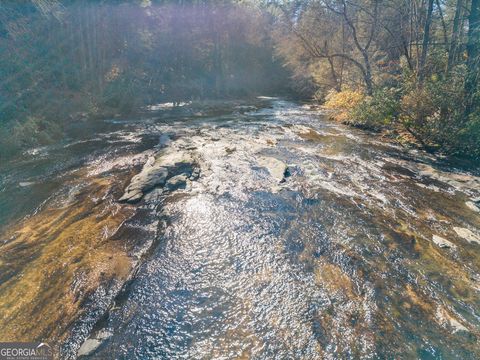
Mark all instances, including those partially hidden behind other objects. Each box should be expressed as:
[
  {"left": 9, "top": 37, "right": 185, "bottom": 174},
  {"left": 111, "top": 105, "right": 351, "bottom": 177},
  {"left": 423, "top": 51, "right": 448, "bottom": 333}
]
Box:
[{"left": 0, "top": 0, "right": 480, "bottom": 159}]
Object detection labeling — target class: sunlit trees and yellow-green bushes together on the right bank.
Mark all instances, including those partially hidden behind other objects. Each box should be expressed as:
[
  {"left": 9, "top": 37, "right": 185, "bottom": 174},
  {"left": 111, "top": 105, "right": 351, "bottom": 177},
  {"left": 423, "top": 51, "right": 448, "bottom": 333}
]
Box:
[{"left": 271, "top": 0, "right": 480, "bottom": 159}]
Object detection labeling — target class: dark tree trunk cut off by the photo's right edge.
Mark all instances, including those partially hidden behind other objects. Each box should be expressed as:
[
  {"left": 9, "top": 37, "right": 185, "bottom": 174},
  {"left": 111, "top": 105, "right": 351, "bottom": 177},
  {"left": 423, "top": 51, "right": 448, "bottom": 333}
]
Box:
[{"left": 465, "top": 0, "right": 480, "bottom": 117}]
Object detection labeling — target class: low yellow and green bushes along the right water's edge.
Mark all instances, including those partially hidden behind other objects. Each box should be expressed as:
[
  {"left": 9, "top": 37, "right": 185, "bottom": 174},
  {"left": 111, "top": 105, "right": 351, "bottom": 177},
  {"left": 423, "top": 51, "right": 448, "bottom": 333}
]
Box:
[{"left": 314, "top": 88, "right": 480, "bottom": 166}]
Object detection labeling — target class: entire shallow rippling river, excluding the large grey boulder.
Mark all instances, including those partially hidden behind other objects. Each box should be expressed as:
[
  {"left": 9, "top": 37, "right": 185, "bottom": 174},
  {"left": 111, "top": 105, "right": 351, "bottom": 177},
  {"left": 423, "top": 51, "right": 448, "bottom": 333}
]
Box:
[{"left": 0, "top": 98, "right": 480, "bottom": 359}]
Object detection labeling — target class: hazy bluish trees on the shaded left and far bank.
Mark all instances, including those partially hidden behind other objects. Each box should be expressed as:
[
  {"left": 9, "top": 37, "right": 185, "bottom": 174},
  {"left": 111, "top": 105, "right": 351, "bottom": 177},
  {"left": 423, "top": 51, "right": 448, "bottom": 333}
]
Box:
[{"left": 0, "top": 0, "right": 288, "bottom": 157}]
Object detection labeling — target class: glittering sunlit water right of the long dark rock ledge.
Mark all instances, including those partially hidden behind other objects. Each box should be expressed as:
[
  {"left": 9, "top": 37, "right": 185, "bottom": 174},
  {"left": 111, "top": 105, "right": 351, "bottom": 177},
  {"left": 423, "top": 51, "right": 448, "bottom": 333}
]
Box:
[{"left": 86, "top": 101, "right": 480, "bottom": 359}]
